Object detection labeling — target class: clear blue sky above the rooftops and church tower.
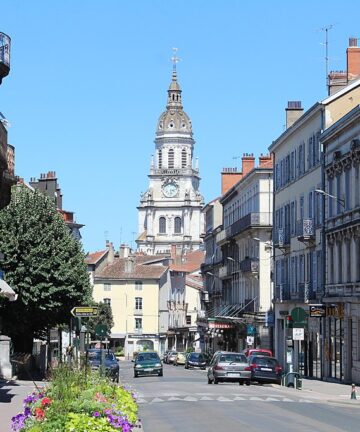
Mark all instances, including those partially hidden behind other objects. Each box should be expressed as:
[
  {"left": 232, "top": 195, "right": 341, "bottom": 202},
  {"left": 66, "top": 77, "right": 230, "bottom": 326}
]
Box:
[{"left": 0, "top": 0, "right": 360, "bottom": 251}]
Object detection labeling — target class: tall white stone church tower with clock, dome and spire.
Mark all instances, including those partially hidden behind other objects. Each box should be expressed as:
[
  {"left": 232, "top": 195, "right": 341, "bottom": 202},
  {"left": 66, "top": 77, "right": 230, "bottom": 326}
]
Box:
[{"left": 136, "top": 63, "right": 203, "bottom": 254}]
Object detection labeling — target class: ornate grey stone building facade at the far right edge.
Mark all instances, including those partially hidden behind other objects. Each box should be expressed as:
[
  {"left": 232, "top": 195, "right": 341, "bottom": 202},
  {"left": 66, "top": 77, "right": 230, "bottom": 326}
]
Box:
[{"left": 321, "top": 105, "right": 360, "bottom": 383}]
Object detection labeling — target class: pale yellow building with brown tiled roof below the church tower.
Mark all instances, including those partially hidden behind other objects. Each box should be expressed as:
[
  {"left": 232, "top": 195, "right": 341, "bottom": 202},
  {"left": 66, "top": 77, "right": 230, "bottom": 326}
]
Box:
[{"left": 88, "top": 245, "right": 170, "bottom": 358}]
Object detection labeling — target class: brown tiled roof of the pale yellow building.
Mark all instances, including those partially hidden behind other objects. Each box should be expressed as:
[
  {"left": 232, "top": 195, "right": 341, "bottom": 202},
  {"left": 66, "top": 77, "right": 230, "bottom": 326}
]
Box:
[{"left": 95, "top": 255, "right": 168, "bottom": 280}]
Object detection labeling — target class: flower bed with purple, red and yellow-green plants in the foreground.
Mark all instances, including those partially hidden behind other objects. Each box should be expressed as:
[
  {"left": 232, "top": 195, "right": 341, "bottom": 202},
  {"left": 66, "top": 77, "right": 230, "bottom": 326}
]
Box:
[{"left": 12, "top": 366, "right": 138, "bottom": 432}]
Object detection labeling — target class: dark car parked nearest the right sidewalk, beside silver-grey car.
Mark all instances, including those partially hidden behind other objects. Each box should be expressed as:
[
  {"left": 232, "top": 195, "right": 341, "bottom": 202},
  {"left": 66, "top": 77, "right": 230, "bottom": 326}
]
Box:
[{"left": 249, "top": 355, "right": 282, "bottom": 384}]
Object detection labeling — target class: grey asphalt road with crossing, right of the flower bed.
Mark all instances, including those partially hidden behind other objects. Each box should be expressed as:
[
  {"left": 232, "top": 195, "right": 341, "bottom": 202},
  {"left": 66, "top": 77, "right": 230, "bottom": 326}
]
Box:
[{"left": 121, "top": 362, "right": 359, "bottom": 432}]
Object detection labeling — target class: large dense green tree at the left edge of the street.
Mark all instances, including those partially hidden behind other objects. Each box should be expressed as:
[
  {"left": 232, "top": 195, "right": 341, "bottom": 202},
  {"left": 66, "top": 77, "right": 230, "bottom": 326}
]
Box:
[{"left": 0, "top": 186, "right": 91, "bottom": 352}]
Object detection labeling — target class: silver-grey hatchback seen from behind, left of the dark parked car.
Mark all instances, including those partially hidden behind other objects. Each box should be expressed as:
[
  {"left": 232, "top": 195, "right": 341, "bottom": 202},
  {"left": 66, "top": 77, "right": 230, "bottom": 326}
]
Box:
[{"left": 207, "top": 351, "right": 251, "bottom": 385}]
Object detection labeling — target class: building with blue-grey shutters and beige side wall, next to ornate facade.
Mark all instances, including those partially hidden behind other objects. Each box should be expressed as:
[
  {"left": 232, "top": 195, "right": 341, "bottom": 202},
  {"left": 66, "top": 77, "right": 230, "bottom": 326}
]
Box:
[{"left": 269, "top": 70, "right": 360, "bottom": 378}]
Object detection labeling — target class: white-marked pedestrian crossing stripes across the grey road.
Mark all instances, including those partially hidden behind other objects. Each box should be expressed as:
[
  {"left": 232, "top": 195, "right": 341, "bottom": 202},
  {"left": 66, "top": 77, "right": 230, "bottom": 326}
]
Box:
[{"left": 136, "top": 394, "right": 314, "bottom": 405}]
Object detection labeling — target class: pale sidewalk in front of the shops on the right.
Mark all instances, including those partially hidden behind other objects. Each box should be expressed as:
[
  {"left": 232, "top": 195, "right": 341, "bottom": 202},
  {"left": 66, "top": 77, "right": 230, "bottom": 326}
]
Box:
[{"left": 289, "top": 378, "right": 360, "bottom": 406}]
